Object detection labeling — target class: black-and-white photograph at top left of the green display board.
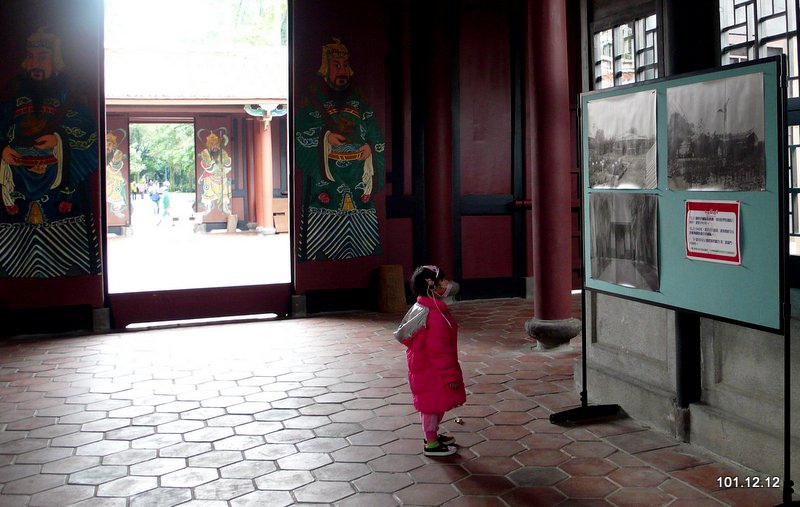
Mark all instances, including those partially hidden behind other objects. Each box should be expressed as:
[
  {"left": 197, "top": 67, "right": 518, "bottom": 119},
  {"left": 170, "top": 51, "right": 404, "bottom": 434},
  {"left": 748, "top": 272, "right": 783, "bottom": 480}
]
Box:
[{"left": 586, "top": 90, "right": 658, "bottom": 189}]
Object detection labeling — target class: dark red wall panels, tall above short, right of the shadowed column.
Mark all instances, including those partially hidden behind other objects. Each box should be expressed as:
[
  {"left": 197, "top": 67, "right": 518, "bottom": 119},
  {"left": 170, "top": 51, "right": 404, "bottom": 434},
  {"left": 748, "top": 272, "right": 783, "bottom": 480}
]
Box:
[{"left": 459, "top": 1, "right": 514, "bottom": 279}]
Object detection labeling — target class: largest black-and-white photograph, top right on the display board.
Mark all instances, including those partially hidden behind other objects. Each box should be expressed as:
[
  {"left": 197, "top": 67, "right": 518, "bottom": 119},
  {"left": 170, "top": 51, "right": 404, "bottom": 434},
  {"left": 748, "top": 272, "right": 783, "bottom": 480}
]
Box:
[{"left": 667, "top": 74, "right": 766, "bottom": 192}]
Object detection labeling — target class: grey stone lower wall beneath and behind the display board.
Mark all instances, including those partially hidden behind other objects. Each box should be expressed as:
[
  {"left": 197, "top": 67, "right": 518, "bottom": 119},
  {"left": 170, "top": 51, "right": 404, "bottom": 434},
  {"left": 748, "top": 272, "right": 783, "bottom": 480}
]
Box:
[{"left": 575, "top": 292, "right": 800, "bottom": 484}]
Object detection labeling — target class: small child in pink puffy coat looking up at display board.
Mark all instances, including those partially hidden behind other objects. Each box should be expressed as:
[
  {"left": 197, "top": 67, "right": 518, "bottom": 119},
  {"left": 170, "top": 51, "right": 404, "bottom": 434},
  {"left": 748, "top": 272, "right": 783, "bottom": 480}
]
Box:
[{"left": 395, "top": 265, "right": 467, "bottom": 456}]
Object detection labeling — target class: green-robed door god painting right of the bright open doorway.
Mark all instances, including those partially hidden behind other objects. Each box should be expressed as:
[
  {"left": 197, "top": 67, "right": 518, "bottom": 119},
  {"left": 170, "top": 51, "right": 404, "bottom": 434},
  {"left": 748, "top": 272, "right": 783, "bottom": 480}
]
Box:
[{"left": 295, "top": 39, "right": 384, "bottom": 260}]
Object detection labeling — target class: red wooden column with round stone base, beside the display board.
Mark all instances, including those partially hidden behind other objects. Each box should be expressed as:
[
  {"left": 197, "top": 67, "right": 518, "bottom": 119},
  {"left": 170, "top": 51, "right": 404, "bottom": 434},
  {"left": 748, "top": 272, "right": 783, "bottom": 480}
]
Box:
[{"left": 524, "top": 0, "right": 581, "bottom": 349}]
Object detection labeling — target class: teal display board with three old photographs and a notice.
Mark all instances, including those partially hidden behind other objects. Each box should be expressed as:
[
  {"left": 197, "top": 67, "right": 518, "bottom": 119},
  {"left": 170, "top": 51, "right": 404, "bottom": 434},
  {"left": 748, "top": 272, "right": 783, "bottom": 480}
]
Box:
[{"left": 581, "top": 58, "right": 787, "bottom": 332}]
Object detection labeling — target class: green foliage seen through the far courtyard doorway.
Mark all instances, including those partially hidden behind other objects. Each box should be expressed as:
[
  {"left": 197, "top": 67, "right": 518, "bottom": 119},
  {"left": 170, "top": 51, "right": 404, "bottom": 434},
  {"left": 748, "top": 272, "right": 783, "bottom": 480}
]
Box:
[{"left": 130, "top": 123, "right": 195, "bottom": 192}]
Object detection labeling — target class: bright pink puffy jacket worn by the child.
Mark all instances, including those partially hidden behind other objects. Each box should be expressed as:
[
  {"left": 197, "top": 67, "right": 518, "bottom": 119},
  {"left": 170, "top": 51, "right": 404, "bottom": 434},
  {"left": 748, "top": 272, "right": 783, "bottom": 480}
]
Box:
[{"left": 403, "top": 296, "right": 467, "bottom": 414}]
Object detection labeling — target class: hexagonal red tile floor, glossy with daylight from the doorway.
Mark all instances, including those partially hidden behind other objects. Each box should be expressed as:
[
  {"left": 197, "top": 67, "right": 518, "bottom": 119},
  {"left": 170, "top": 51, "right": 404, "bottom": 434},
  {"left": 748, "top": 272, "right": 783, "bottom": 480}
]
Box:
[{"left": 0, "top": 299, "right": 781, "bottom": 507}]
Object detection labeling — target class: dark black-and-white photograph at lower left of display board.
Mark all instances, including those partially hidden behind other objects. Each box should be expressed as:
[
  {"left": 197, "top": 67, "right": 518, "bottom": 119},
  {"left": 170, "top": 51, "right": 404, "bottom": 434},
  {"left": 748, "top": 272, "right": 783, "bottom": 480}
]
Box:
[{"left": 589, "top": 192, "right": 660, "bottom": 291}]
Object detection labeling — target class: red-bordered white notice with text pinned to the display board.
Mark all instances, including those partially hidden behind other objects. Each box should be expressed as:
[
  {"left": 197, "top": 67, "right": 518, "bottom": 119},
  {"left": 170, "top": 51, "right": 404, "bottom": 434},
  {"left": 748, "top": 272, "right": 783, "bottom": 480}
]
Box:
[{"left": 686, "top": 200, "right": 742, "bottom": 265}]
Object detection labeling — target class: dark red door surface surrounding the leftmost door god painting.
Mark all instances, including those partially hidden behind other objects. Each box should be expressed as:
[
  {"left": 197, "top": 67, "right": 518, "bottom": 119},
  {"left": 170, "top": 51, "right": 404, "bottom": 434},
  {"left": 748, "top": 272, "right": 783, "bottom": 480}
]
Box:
[{"left": 0, "top": 0, "right": 105, "bottom": 310}]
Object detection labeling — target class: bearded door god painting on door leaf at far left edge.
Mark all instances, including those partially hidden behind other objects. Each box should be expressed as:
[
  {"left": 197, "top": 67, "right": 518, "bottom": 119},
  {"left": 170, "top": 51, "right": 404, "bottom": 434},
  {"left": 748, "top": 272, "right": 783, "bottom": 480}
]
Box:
[{"left": 0, "top": 29, "right": 100, "bottom": 278}]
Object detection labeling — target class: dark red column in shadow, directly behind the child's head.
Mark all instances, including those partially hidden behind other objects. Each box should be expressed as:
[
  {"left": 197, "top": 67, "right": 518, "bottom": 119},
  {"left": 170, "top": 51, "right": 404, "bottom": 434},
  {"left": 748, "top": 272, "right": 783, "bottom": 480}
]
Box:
[{"left": 425, "top": 2, "right": 454, "bottom": 278}]
